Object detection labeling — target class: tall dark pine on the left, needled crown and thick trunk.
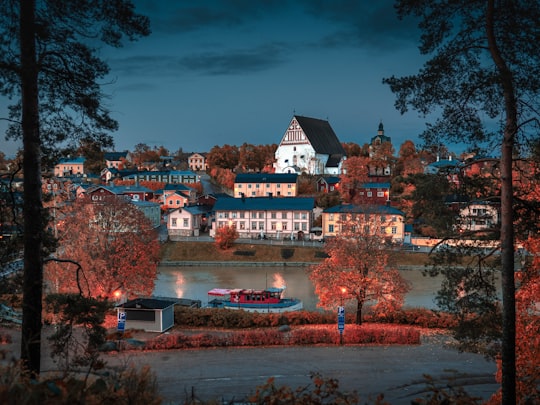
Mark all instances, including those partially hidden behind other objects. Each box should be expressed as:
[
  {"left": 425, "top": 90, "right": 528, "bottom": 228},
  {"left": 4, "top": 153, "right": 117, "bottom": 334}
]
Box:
[{"left": 0, "top": 0, "right": 150, "bottom": 374}]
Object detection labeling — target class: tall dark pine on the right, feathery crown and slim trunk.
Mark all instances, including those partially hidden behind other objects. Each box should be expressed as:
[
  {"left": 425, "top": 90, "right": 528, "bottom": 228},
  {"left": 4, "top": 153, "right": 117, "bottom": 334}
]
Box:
[{"left": 383, "top": 0, "right": 540, "bottom": 404}]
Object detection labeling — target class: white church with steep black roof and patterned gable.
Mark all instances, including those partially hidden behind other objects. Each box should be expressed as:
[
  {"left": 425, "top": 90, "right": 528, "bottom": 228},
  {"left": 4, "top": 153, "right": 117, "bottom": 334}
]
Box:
[{"left": 274, "top": 115, "right": 346, "bottom": 175}]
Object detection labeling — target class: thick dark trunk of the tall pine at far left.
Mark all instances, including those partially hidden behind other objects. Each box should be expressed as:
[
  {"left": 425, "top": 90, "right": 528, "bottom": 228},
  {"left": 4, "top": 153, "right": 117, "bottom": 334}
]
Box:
[{"left": 19, "top": 0, "right": 44, "bottom": 376}]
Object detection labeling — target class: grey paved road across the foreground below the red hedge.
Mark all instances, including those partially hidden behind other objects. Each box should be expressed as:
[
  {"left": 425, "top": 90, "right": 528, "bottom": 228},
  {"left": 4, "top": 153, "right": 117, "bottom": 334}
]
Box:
[{"left": 0, "top": 326, "right": 498, "bottom": 405}]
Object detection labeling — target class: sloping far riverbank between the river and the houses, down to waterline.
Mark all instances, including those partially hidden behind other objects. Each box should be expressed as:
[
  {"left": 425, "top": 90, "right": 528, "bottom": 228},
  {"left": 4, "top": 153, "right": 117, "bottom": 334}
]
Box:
[{"left": 160, "top": 241, "right": 428, "bottom": 268}]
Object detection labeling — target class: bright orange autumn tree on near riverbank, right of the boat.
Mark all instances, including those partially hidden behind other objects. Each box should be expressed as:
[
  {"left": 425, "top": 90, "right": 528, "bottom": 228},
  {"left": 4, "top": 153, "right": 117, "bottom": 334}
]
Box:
[{"left": 309, "top": 214, "right": 410, "bottom": 324}]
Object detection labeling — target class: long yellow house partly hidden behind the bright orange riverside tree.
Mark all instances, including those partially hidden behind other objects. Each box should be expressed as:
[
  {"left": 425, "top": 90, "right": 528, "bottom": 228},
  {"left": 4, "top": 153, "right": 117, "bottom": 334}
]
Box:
[{"left": 322, "top": 204, "right": 405, "bottom": 244}]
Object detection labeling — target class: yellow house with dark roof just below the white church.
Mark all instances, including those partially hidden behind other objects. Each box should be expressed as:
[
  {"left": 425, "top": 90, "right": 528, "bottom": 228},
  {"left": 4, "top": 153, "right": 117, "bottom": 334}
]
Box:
[{"left": 234, "top": 173, "right": 298, "bottom": 198}]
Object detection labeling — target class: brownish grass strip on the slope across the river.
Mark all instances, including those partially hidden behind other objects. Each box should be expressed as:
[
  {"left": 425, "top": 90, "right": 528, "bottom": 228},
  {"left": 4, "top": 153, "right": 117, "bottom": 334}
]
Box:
[{"left": 161, "top": 241, "right": 427, "bottom": 266}]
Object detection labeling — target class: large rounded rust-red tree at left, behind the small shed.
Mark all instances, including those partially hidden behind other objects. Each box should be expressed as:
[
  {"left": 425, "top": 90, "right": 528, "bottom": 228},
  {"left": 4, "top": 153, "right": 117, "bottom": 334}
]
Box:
[{"left": 45, "top": 196, "right": 159, "bottom": 300}]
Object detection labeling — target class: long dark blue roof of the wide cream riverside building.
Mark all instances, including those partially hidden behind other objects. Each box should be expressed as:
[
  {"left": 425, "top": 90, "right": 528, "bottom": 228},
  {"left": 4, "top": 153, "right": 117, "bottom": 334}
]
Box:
[{"left": 214, "top": 197, "right": 315, "bottom": 211}]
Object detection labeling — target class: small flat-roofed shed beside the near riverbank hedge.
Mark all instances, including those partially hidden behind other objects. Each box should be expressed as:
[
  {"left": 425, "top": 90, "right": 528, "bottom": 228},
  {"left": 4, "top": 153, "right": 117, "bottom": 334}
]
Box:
[{"left": 117, "top": 298, "right": 176, "bottom": 332}]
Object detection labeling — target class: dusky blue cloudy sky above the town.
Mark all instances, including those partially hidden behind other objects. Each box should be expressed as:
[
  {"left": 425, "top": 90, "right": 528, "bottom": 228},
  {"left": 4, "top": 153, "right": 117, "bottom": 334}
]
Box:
[{"left": 0, "top": 0, "right": 442, "bottom": 156}]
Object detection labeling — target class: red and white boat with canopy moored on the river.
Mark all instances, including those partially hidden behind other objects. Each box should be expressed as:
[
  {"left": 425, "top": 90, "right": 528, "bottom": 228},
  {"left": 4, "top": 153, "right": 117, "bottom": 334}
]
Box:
[{"left": 208, "top": 287, "right": 304, "bottom": 313}]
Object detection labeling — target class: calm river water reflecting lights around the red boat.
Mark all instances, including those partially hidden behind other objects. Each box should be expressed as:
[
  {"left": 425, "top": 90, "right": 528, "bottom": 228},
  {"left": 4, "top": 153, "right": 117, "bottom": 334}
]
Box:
[{"left": 154, "top": 266, "right": 441, "bottom": 311}]
